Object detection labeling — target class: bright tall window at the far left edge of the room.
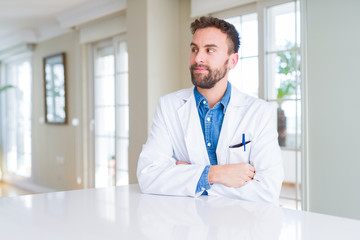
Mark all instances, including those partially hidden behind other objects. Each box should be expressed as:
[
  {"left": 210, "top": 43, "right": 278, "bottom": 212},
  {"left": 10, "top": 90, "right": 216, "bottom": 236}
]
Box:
[{"left": 1, "top": 59, "right": 32, "bottom": 178}]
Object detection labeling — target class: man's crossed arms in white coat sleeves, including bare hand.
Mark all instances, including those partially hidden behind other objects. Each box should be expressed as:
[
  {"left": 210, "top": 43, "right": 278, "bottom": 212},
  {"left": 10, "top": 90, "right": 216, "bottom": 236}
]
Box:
[{"left": 137, "top": 95, "right": 283, "bottom": 202}]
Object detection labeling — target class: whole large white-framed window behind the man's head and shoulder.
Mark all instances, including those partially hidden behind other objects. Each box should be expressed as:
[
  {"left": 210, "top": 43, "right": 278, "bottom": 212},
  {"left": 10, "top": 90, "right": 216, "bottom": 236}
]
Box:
[{"left": 221, "top": 1, "right": 302, "bottom": 209}]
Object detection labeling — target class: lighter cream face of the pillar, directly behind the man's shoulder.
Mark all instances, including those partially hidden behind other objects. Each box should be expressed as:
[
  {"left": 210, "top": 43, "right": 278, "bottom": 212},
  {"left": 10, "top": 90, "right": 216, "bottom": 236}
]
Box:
[{"left": 147, "top": 0, "right": 182, "bottom": 127}]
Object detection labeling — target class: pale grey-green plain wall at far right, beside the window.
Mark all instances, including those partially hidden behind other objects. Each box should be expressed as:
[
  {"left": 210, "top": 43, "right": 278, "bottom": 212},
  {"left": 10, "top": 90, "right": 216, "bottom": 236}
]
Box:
[{"left": 306, "top": 0, "right": 360, "bottom": 219}]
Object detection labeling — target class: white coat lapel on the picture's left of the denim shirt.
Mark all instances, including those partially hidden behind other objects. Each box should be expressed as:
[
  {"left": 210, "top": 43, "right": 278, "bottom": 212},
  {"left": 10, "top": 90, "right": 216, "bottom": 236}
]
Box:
[{"left": 178, "top": 88, "right": 210, "bottom": 164}]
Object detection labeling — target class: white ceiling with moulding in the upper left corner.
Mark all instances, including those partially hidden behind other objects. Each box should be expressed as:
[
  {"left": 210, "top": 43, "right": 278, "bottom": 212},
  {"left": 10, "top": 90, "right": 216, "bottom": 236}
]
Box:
[{"left": 0, "top": 0, "right": 126, "bottom": 53}]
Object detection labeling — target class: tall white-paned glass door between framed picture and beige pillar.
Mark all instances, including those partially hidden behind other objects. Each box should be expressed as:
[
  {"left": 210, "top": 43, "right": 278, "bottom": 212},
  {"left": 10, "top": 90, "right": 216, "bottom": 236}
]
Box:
[{"left": 92, "top": 37, "right": 129, "bottom": 187}]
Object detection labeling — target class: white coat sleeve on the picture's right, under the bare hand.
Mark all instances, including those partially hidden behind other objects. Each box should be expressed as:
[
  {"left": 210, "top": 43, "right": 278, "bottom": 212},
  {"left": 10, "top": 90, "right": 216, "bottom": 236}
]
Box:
[{"left": 209, "top": 105, "right": 284, "bottom": 203}]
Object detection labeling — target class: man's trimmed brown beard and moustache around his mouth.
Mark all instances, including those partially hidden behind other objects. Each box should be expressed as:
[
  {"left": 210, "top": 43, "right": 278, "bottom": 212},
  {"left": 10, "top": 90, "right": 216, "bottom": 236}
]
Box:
[{"left": 190, "top": 59, "right": 229, "bottom": 89}]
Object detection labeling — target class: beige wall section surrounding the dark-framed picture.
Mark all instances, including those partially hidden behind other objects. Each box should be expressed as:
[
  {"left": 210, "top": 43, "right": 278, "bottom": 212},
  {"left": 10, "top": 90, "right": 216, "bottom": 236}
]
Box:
[{"left": 31, "top": 32, "right": 83, "bottom": 190}]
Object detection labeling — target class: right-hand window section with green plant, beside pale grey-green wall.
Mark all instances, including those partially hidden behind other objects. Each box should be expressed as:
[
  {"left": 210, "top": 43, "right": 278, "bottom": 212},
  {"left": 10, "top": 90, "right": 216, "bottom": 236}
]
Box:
[{"left": 265, "top": 1, "right": 301, "bottom": 209}]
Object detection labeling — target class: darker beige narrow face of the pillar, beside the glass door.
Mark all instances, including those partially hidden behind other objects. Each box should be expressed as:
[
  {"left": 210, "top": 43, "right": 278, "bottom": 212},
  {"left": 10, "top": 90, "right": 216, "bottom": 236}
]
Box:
[{"left": 126, "top": 1, "right": 148, "bottom": 183}]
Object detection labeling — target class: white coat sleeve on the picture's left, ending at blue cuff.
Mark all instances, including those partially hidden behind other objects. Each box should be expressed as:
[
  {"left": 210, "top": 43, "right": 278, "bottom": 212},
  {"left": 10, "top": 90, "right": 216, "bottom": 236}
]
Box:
[{"left": 137, "top": 97, "right": 205, "bottom": 197}]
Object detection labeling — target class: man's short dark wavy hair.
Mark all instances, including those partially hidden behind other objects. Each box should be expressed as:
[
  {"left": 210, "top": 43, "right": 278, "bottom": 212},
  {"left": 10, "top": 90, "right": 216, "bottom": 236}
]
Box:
[{"left": 190, "top": 17, "right": 240, "bottom": 54}]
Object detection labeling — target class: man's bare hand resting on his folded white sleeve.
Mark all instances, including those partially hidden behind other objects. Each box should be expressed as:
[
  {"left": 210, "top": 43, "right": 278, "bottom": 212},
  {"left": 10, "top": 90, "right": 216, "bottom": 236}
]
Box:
[{"left": 209, "top": 163, "right": 255, "bottom": 188}]
